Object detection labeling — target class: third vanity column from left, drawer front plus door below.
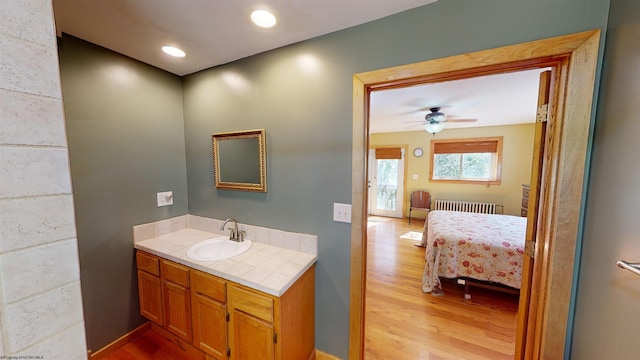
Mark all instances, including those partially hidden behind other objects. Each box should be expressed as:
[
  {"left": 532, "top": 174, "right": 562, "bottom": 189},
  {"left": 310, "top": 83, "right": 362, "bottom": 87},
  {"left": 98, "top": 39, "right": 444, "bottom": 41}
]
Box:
[{"left": 191, "top": 269, "right": 228, "bottom": 360}]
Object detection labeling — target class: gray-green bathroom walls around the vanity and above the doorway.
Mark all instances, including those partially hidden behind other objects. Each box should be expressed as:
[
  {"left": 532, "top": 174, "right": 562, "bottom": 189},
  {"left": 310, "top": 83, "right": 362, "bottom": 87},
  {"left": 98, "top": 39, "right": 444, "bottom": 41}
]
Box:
[{"left": 60, "top": 0, "right": 609, "bottom": 358}]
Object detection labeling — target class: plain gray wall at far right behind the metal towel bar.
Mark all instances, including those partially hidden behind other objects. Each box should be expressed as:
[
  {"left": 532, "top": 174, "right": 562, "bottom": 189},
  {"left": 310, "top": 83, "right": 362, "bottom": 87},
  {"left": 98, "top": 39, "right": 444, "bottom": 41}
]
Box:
[{"left": 571, "top": 0, "right": 640, "bottom": 360}]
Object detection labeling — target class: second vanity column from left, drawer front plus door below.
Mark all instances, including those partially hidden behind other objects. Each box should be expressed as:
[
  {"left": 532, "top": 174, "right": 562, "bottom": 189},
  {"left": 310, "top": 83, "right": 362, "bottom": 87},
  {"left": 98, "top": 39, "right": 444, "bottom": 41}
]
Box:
[{"left": 160, "top": 259, "right": 193, "bottom": 342}]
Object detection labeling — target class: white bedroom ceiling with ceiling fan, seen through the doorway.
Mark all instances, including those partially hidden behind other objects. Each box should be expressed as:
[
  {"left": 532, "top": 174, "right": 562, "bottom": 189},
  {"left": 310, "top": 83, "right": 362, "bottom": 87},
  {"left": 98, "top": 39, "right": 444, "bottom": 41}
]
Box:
[{"left": 369, "top": 69, "right": 544, "bottom": 133}]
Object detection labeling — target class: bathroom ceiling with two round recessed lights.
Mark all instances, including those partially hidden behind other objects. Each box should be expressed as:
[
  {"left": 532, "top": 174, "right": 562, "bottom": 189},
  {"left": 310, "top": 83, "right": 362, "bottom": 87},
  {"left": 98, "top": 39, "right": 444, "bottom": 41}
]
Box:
[{"left": 53, "top": 0, "right": 437, "bottom": 76}]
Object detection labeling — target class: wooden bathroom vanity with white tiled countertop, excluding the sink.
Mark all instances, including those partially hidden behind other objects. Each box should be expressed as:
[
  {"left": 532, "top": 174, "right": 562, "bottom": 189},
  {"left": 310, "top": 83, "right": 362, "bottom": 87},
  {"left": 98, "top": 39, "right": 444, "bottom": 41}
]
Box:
[{"left": 134, "top": 229, "right": 316, "bottom": 359}]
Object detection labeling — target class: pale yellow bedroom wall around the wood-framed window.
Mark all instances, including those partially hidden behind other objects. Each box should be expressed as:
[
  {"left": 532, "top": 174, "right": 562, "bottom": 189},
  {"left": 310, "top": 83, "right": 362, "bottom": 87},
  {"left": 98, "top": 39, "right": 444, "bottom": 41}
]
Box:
[{"left": 369, "top": 124, "right": 534, "bottom": 217}]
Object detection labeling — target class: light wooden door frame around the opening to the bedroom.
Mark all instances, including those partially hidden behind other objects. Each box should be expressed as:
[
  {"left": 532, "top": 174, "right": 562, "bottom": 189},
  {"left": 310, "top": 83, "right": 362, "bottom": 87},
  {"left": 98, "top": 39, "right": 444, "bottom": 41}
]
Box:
[{"left": 349, "top": 30, "right": 600, "bottom": 360}]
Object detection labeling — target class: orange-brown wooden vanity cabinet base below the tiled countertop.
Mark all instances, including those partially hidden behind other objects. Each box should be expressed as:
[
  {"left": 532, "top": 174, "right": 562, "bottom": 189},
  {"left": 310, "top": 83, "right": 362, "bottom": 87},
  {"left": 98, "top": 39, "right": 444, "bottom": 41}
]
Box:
[{"left": 136, "top": 251, "right": 315, "bottom": 360}]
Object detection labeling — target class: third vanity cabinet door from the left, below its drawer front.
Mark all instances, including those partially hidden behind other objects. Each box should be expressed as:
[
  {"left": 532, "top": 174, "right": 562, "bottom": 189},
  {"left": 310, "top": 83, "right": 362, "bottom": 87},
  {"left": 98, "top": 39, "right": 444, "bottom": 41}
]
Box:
[{"left": 193, "top": 294, "right": 227, "bottom": 360}]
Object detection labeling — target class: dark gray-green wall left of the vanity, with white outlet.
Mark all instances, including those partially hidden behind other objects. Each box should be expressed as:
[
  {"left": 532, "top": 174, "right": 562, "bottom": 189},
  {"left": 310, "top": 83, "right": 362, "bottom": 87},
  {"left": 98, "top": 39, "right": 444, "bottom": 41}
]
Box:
[{"left": 58, "top": 35, "right": 187, "bottom": 351}]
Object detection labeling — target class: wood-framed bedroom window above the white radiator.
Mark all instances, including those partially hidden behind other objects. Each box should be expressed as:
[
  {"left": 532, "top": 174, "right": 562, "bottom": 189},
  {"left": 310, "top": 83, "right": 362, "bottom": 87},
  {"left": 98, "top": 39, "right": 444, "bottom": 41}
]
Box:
[{"left": 429, "top": 136, "right": 502, "bottom": 184}]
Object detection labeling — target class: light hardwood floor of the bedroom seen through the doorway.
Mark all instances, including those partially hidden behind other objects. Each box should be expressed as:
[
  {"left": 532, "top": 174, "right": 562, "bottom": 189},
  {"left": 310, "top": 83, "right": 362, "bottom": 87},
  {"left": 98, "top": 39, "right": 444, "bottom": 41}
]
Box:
[{"left": 364, "top": 217, "right": 518, "bottom": 360}]
